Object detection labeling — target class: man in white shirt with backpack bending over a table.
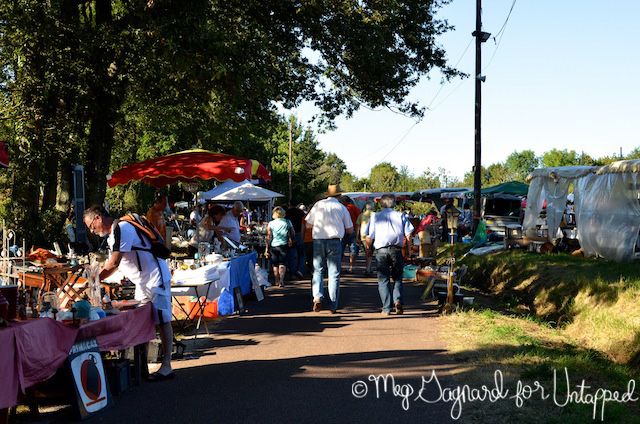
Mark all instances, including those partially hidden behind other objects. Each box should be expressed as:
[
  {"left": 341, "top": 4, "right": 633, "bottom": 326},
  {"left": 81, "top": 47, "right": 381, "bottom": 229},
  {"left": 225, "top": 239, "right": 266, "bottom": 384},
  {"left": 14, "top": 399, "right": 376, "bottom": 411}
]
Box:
[{"left": 83, "top": 206, "right": 174, "bottom": 381}]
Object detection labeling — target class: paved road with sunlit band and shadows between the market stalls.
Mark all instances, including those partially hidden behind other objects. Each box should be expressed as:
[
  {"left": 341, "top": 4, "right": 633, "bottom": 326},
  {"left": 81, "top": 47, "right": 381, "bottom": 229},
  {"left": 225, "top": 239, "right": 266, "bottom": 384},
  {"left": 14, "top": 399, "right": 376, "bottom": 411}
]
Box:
[{"left": 85, "top": 264, "right": 457, "bottom": 423}]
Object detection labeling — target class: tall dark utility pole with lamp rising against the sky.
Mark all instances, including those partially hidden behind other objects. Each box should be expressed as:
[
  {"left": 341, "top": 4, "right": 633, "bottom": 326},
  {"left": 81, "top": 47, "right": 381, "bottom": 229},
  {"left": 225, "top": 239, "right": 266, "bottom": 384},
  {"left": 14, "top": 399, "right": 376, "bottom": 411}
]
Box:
[{"left": 471, "top": 0, "right": 491, "bottom": 232}]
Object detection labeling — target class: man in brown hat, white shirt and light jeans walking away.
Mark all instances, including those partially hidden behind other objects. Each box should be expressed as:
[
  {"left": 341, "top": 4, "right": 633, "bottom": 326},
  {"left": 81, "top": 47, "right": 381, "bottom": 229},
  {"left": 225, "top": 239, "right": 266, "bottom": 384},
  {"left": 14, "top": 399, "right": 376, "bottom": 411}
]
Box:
[{"left": 305, "top": 185, "right": 353, "bottom": 313}]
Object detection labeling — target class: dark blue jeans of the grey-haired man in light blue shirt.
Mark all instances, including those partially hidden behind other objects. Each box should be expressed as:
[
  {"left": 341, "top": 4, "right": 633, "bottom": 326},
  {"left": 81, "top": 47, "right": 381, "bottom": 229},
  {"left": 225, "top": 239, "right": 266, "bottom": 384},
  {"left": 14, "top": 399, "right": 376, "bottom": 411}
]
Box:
[{"left": 375, "top": 247, "right": 404, "bottom": 312}]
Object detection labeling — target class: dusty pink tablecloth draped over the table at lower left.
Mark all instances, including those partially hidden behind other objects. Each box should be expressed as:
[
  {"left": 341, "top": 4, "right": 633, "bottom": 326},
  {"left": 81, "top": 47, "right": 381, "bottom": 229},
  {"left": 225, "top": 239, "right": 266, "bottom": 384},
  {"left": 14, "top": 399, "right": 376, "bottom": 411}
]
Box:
[{"left": 0, "top": 304, "right": 155, "bottom": 409}]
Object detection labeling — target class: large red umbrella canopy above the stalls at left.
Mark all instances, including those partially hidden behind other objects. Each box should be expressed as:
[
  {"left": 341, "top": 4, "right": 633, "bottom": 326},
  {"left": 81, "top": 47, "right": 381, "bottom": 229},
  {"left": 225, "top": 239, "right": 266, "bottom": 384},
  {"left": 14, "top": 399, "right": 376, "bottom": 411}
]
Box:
[{"left": 107, "top": 150, "right": 271, "bottom": 187}]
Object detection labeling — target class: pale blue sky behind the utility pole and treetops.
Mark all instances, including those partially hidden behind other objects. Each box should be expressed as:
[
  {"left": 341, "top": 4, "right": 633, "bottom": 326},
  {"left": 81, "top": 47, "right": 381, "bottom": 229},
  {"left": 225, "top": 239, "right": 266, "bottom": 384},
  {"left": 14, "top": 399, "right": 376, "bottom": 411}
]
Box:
[{"left": 293, "top": 0, "right": 640, "bottom": 178}]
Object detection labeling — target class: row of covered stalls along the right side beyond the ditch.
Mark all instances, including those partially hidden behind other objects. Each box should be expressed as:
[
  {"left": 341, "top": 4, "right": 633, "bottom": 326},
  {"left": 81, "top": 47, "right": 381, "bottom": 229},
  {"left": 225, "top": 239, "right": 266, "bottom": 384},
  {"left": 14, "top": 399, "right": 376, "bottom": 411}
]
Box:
[{"left": 360, "top": 159, "right": 640, "bottom": 261}]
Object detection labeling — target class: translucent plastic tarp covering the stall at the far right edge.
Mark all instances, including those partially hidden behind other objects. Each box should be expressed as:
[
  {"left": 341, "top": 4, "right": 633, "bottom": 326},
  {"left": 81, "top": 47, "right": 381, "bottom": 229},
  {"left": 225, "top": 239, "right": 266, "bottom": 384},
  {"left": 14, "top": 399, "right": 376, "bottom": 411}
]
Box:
[{"left": 574, "top": 172, "right": 640, "bottom": 261}]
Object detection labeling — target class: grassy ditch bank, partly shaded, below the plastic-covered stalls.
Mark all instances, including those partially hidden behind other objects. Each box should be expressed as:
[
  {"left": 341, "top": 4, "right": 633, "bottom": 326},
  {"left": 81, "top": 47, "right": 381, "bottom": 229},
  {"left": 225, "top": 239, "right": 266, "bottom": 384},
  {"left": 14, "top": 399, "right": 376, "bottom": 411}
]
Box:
[{"left": 464, "top": 251, "right": 640, "bottom": 366}]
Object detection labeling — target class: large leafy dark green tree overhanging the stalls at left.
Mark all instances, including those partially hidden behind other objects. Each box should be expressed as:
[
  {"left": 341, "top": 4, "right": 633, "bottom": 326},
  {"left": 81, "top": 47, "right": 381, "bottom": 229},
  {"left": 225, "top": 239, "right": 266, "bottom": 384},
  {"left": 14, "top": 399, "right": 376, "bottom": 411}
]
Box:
[{"left": 0, "top": 0, "right": 460, "bottom": 243}]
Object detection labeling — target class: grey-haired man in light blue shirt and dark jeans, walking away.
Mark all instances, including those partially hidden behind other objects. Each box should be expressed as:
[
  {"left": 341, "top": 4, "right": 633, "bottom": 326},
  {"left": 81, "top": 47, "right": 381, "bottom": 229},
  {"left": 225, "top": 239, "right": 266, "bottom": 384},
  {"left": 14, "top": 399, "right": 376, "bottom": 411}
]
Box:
[{"left": 366, "top": 194, "right": 413, "bottom": 316}]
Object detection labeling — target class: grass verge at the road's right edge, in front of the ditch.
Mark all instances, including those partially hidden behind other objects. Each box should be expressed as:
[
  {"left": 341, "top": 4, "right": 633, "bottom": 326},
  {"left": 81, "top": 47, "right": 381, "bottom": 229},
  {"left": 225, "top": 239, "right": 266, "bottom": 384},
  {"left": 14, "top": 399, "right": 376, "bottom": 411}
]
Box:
[{"left": 443, "top": 310, "right": 640, "bottom": 424}]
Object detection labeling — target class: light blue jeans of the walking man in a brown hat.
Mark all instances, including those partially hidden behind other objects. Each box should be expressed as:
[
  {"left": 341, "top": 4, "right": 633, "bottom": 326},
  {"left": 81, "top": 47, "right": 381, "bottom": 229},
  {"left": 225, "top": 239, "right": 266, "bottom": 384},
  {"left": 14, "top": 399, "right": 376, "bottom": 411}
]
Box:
[{"left": 311, "top": 239, "right": 342, "bottom": 310}]
